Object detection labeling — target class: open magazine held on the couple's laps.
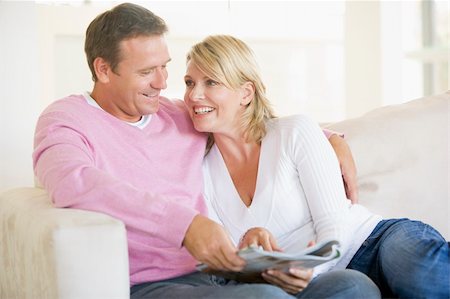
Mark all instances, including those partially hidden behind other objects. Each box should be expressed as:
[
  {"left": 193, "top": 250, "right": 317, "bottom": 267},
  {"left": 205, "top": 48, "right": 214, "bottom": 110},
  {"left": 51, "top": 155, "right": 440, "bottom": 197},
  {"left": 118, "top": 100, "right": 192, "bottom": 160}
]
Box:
[{"left": 197, "top": 240, "right": 341, "bottom": 282}]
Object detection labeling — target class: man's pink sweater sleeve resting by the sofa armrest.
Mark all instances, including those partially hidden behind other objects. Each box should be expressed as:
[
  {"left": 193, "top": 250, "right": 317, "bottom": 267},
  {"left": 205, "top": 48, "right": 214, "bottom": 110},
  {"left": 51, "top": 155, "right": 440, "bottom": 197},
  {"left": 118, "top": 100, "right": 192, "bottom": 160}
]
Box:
[{"left": 33, "top": 113, "right": 199, "bottom": 247}]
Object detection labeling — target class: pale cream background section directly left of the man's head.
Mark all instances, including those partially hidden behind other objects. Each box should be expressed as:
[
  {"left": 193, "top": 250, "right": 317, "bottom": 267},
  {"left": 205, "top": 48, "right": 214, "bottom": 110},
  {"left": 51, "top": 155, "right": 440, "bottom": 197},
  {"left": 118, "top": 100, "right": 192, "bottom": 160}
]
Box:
[{"left": 35, "top": 1, "right": 112, "bottom": 107}]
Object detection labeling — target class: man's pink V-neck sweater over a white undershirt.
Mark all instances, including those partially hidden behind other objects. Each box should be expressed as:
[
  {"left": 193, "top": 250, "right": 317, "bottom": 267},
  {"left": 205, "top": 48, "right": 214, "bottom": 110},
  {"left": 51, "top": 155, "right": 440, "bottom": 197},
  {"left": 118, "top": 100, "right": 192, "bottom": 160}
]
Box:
[{"left": 33, "top": 95, "right": 206, "bottom": 285}]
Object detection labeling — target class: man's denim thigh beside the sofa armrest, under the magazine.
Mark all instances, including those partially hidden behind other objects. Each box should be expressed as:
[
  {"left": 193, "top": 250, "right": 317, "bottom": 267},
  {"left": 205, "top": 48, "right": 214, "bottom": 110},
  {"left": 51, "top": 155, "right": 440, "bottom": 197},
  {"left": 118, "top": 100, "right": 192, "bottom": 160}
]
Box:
[{"left": 130, "top": 273, "right": 295, "bottom": 299}]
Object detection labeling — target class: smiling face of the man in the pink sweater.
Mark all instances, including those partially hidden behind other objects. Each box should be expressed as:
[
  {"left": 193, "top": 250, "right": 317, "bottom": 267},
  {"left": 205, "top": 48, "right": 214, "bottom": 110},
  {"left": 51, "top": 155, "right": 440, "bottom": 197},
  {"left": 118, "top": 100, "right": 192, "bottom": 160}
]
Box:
[{"left": 105, "top": 35, "right": 170, "bottom": 122}]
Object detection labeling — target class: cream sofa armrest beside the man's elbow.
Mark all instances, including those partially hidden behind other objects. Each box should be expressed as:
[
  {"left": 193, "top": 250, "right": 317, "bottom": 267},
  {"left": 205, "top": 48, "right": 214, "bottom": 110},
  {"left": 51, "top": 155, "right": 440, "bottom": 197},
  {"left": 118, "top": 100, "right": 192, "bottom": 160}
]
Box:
[{"left": 0, "top": 188, "right": 130, "bottom": 299}]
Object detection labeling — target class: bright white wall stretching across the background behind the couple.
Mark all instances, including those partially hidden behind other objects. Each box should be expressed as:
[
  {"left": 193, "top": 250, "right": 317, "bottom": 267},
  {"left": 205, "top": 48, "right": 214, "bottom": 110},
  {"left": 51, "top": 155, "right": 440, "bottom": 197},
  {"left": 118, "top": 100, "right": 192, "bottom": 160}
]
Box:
[{"left": 0, "top": 1, "right": 442, "bottom": 191}]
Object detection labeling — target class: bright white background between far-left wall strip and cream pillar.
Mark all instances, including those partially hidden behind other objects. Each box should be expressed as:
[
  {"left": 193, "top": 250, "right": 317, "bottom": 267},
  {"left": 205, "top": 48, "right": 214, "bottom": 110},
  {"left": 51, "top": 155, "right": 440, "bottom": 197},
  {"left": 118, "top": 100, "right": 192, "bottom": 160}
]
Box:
[{"left": 38, "top": 1, "right": 345, "bottom": 121}]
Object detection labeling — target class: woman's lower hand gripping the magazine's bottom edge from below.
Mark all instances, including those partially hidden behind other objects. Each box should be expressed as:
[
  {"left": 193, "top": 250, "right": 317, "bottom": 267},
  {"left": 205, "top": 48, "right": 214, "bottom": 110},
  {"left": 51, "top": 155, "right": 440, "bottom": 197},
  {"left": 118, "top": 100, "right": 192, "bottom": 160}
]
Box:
[{"left": 262, "top": 268, "right": 313, "bottom": 294}]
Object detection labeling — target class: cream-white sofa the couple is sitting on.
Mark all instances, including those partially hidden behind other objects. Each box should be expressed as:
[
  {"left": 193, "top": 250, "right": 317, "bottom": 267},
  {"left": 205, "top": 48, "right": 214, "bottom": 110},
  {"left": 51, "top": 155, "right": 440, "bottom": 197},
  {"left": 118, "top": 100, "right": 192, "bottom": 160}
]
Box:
[{"left": 0, "top": 92, "right": 450, "bottom": 299}]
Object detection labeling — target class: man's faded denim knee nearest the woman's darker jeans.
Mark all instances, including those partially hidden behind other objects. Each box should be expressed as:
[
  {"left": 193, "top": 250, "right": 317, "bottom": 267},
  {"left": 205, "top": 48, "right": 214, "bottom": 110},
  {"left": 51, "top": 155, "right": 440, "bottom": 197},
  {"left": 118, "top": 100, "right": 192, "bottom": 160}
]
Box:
[{"left": 296, "top": 269, "right": 381, "bottom": 299}]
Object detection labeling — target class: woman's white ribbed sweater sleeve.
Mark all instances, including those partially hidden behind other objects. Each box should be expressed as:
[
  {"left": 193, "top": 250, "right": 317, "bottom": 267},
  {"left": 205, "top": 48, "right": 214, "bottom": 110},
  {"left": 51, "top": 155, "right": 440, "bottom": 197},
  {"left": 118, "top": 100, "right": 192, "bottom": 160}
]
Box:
[{"left": 290, "top": 116, "right": 351, "bottom": 245}]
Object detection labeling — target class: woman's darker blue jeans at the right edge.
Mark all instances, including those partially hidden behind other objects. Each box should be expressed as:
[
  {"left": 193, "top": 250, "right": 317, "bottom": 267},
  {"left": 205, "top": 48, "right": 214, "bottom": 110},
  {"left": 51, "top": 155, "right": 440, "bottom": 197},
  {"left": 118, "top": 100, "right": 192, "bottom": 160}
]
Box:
[{"left": 347, "top": 219, "right": 450, "bottom": 298}]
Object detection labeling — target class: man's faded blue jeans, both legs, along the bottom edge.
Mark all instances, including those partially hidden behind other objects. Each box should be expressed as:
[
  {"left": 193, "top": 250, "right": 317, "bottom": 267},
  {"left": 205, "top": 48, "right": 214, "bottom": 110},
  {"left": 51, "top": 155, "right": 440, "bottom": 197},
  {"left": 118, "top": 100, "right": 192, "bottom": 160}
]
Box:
[{"left": 131, "top": 270, "right": 380, "bottom": 299}]
